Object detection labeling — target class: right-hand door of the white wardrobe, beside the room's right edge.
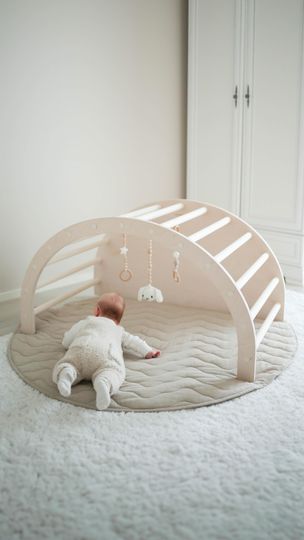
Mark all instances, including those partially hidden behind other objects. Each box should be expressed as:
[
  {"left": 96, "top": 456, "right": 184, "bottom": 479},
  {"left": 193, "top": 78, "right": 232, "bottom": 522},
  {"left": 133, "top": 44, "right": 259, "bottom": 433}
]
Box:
[{"left": 241, "top": 0, "right": 304, "bottom": 234}]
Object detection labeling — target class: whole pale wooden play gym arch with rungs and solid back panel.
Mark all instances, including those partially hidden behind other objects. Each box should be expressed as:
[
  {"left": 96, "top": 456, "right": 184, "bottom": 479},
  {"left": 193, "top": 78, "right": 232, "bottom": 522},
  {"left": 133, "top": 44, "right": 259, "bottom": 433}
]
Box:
[{"left": 20, "top": 199, "right": 285, "bottom": 382}]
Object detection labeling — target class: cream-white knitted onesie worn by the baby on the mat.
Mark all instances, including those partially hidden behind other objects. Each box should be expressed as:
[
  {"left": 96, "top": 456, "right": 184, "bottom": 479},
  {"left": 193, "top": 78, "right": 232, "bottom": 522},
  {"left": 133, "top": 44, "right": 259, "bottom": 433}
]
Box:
[{"left": 52, "top": 315, "right": 153, "bottom": 394}]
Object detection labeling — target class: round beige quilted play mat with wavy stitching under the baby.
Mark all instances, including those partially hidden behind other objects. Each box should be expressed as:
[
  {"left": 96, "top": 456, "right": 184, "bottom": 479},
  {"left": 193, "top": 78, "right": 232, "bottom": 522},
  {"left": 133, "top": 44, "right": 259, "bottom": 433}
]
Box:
[{"left": 10, "top": 298, "right": 297, "bottom": 411}]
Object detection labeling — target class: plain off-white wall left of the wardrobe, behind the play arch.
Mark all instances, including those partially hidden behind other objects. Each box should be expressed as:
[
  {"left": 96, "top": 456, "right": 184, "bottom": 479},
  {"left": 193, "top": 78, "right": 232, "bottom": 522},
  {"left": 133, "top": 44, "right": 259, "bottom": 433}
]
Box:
[{"left": 0, "top": 0, "right": 187, "bottom": 297}]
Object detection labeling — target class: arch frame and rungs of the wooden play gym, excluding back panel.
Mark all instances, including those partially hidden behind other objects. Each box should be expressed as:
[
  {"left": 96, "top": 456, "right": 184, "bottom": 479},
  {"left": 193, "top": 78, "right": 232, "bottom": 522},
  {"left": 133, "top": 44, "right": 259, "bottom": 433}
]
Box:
[{"left": 21, "top": 199, "right": 285, "bottom": 382}]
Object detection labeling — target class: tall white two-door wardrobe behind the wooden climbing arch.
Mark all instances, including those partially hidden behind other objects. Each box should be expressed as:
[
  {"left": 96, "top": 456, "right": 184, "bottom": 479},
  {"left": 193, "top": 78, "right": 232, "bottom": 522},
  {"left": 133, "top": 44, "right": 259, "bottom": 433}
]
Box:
[{"left": 187, "top": 0, "right": 304, "bottom": 284}]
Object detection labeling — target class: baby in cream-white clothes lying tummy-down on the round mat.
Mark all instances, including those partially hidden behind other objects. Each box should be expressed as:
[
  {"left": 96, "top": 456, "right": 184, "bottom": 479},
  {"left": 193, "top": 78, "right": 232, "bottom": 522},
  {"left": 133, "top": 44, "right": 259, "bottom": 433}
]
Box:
[{"left": 53, "top": 293, "right": 160, "bottom": 411}]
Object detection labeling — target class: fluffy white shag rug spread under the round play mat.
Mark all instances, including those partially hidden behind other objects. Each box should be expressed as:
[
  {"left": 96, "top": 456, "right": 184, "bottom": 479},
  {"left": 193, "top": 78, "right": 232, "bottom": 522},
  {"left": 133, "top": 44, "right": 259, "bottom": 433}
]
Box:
[{"left": 0, "top": 291, "right": 304, "bottom": 540}]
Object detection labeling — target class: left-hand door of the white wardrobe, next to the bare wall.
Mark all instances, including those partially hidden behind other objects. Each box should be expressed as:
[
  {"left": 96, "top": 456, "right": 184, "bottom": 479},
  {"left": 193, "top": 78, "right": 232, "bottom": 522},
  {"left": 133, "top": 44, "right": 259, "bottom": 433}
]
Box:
[{"left": 187, "top": 0, "right": 243, "bottom": 213}]
